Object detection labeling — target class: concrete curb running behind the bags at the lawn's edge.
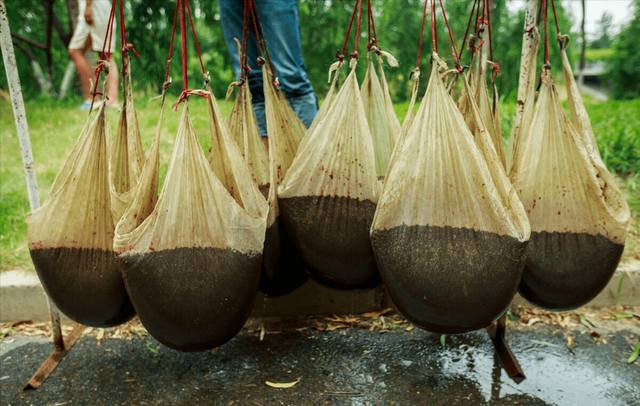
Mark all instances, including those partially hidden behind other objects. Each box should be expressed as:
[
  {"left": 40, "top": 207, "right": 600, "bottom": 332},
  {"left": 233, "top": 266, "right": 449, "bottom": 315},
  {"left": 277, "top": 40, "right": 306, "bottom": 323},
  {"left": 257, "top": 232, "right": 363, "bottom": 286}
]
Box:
[{"left": 0, "top": 264, "right": 640, "bottom": 323}]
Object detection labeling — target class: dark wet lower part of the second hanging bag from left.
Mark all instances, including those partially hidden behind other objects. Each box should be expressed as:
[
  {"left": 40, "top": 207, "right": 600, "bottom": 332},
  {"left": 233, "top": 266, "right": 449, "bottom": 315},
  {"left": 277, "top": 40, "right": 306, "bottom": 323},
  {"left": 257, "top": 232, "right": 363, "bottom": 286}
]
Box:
[{"left": 123, "top": 247, "right": 261, "bottom": 351}]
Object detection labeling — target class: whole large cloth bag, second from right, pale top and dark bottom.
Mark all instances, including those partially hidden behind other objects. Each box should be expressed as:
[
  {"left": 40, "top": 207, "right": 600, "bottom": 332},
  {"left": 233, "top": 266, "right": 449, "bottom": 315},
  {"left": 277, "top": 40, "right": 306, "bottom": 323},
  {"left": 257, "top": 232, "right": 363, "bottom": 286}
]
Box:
[{"left": 371, "top": 53, "right": 529, "bottom": 334}]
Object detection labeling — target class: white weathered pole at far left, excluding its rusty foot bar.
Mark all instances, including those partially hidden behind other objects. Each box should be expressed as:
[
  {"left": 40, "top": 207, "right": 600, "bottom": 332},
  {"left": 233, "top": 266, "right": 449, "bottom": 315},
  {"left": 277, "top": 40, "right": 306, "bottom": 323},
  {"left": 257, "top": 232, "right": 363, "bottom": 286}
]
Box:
[{"left": 0, "top": 0, "right": 64, "bottom": 349}]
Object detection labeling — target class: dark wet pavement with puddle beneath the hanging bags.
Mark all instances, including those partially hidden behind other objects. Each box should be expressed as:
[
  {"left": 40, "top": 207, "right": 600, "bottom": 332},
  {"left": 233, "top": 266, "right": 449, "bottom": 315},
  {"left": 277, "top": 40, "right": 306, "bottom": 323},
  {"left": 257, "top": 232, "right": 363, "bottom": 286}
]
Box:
[{"left": 0, "top": 319, "right": 640, "bottom": 406}]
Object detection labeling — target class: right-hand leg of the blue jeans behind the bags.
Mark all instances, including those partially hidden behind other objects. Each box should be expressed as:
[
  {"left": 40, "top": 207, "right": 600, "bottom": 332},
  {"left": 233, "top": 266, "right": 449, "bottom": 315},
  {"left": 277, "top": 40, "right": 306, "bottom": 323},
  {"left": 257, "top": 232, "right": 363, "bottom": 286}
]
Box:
[{"left": 256, "top": 0, "right": 318, "bottom": 127}]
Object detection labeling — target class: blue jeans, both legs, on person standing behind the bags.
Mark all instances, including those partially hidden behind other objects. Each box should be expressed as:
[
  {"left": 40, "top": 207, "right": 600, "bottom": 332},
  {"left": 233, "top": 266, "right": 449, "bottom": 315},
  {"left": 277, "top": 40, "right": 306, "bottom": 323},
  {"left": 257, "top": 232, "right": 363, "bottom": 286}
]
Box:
[{"left": 218, "top": 0, "right": 318, "bottom": 137}]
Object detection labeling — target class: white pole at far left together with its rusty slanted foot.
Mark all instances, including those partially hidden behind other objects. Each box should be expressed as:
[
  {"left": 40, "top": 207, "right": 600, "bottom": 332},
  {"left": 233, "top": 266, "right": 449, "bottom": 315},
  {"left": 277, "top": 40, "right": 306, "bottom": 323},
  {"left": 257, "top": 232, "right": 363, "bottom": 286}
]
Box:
[{"left": 0, "top": 0, "right": 84, "bottom": 389}]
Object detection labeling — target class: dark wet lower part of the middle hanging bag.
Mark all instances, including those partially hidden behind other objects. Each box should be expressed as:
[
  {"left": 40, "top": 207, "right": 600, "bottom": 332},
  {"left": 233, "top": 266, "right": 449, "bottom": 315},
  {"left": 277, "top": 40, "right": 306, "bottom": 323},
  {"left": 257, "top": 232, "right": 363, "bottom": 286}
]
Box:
[{"left": 280, "top": 196, "right": 381, "bottom": 289}]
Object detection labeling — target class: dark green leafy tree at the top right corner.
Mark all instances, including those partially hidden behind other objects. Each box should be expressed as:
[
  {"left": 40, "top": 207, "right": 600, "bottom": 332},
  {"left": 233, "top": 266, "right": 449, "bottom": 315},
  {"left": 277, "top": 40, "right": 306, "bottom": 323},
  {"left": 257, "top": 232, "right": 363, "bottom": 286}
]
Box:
[{"left": 603, "top": 0, "right": 640, "bottom": 100}]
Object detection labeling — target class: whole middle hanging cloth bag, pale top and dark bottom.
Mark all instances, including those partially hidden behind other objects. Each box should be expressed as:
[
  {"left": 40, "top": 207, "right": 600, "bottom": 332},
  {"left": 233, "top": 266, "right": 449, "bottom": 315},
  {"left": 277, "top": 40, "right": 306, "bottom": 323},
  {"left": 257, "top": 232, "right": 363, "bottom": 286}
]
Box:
[{"left": 278, "top": 59, "right": 380, "bottom": 289}]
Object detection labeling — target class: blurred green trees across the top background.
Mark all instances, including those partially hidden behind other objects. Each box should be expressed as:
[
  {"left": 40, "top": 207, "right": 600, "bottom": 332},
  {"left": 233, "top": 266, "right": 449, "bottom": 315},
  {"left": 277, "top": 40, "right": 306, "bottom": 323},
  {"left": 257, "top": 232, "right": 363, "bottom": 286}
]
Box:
[{"left": 0, "top": 0, "right": 640, "bottom": 102}]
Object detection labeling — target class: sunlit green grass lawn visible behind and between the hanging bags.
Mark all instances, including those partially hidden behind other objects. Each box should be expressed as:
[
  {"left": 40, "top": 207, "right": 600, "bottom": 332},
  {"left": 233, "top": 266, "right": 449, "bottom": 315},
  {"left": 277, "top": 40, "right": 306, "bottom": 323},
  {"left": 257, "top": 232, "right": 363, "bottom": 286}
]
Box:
[{"left": 0, "top": 91, "right": 640, "bottom": 270}]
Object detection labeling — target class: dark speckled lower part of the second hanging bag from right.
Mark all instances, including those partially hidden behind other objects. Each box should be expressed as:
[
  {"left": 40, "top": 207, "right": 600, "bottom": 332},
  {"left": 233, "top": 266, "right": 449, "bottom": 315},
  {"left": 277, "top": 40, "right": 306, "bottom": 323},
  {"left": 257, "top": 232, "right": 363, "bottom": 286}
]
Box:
[{"left": 371, "top": 226, "right": 524, "bottom": 334}]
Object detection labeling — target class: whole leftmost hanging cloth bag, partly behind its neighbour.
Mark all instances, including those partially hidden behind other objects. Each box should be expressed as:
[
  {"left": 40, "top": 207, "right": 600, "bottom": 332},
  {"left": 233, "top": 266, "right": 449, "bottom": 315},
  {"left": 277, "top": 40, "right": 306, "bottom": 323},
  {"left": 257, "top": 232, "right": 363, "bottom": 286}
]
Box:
[{"left": 26, "top": 103, "right": 135, "bottom": 327}]
